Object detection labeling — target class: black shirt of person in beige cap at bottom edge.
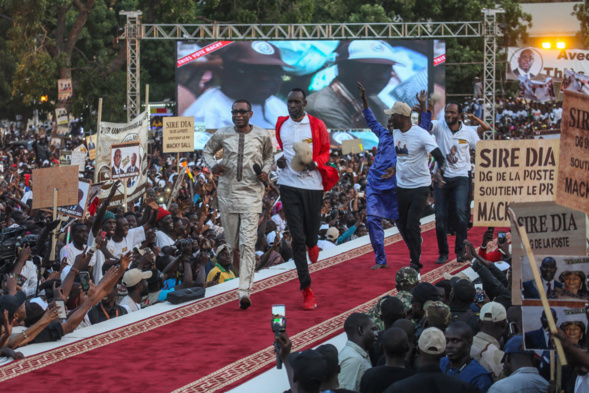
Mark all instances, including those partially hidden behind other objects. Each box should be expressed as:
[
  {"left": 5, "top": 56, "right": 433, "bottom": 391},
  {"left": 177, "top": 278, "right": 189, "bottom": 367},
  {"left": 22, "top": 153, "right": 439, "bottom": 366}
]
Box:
[{"left": 385, "top": 365, "right": 481, "bottom": 393}]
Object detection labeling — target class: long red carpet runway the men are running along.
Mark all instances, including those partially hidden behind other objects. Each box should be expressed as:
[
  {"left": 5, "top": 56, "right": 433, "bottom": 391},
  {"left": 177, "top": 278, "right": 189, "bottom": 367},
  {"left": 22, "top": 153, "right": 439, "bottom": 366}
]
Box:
[{"left": 0, "top": 223, "right": 486, "bottom": 392}]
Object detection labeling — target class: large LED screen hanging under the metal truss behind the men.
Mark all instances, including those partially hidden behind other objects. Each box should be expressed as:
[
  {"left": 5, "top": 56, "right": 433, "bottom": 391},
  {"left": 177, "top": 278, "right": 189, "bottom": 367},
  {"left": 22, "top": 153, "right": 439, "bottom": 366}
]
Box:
[{"left": 176, "top": 40, "right": 446, "bottom": 130}]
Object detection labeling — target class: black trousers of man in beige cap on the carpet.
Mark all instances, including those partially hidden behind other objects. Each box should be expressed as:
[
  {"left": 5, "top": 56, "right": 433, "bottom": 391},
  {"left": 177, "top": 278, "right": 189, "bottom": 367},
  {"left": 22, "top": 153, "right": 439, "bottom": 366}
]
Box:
[{"left": 397, "top": 186, "right": 429, "bottom": 269}]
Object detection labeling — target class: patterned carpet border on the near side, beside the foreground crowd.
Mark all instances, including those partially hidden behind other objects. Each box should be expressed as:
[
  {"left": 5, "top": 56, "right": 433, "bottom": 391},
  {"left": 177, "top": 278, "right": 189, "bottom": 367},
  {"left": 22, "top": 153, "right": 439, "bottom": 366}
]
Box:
[{"left": 173, "top": 250, "right": 468, "bottom": 393}]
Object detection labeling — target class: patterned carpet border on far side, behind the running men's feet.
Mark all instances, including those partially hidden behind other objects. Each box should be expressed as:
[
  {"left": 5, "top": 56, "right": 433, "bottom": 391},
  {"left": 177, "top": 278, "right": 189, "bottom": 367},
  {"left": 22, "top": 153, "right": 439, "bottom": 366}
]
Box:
[{"left": 0, "top": 222, "right": 424, "bottom": 382}]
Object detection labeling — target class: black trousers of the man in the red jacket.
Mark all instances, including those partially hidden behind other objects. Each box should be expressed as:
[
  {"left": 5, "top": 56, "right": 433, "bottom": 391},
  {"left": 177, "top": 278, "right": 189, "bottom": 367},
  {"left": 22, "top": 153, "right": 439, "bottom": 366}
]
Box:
[{"left": 280, "top": 186, "right": 323, "bottom": 290}]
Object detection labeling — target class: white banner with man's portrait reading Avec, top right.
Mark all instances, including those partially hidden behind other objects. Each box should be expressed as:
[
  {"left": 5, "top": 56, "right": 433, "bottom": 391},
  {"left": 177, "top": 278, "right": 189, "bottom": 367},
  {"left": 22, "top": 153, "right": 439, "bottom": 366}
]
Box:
[{"left": 507, "top": 46, "right": 589, "bottom": 82}]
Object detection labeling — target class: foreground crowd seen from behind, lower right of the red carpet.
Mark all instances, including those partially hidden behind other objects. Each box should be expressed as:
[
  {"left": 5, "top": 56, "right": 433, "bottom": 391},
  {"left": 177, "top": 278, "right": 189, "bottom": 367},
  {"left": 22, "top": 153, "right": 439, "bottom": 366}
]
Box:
[{"left": 276, "top": 231, "right": 589, "bottom": 393}]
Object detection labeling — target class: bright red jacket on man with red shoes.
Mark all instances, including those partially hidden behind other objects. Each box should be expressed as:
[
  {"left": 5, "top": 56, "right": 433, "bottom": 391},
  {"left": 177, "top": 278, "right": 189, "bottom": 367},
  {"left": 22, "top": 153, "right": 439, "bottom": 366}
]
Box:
[{"left": 276, "top": 115, "right": 339, "bottom": 191}]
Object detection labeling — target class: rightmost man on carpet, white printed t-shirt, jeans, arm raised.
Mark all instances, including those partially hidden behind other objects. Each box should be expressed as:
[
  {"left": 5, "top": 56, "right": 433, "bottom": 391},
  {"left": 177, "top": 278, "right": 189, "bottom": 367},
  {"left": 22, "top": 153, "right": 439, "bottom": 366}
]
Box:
[{"left": 431, "top": 102, "right": 491, "bottom": 264}]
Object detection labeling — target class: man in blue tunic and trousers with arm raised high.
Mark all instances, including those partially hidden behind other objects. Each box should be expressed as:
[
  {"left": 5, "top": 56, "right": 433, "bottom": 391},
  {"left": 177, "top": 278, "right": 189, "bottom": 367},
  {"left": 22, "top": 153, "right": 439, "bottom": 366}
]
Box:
[{"left": 358, "top": 82, "right": 432, "bottom": 269}]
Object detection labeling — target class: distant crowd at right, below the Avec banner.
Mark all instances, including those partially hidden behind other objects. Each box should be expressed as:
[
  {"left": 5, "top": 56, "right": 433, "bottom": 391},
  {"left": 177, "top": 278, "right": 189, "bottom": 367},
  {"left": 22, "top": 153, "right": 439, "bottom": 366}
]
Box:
[{"left": 463, "top": 97, "right": 562, "bottom": 139}]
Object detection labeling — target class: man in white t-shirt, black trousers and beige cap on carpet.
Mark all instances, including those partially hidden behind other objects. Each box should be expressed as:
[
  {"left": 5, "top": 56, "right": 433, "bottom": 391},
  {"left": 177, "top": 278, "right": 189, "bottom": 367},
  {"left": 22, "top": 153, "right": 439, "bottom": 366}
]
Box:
[{"left": 385, "top": 101, "right": 446, "bottom": 272}]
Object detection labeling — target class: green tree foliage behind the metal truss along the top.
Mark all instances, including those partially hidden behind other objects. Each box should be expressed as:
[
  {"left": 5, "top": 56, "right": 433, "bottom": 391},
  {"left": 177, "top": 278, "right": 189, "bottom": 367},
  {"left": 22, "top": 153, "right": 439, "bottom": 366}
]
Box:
[{"left": 0, "top": 0, "right": 532, "bottom": 128}]
